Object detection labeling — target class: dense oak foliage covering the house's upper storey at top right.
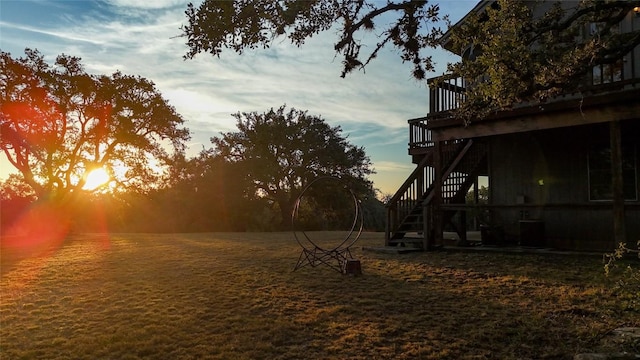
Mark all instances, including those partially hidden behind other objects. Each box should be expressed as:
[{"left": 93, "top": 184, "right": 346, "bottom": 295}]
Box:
[{"left": 449, "top": 0, "right": 640, "bottom": 120}]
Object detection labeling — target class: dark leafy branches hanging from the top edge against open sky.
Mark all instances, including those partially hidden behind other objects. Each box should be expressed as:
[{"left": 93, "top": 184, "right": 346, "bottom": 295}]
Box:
[{"left": 182, "top": 0, "right": 446, "bottom": 79}]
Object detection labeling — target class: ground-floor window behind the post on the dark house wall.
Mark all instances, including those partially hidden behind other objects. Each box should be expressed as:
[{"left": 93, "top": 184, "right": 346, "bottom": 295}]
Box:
[{"left": 589, "top": 146, "right": 638, "bottom": 201}]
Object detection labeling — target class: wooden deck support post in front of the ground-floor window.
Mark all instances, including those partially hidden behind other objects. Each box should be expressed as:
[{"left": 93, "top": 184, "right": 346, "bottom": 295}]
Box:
[{"left": 609, "top": 120, "right": 627, "bottom": 248}]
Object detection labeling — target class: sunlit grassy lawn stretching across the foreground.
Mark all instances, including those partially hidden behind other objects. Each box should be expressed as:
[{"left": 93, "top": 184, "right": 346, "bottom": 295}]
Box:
[{"left": 0, "top": 233, "right": 640, "bottom": 360}]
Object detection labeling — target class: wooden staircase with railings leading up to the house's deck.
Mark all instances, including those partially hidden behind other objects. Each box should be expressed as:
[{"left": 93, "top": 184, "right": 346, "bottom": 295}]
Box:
[{"left": 385, "top": 139, "right": 487, "bottom": 249}]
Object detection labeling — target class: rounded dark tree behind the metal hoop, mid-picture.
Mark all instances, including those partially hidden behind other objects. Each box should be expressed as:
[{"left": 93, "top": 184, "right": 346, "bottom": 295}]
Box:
[{"left": 211, "top": 106, "right": 373, "bottom": 225}]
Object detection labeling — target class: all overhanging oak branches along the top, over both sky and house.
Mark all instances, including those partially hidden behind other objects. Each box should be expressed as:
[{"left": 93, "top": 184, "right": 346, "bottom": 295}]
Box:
[{"left": 183, "top": 0, "right": 640, "bottom": 111}]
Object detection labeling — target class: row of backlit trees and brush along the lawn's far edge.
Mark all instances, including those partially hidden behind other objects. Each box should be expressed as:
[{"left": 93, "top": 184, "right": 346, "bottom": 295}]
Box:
[{"left": 0, "top": 49, "right": 384, "bottom": 233}]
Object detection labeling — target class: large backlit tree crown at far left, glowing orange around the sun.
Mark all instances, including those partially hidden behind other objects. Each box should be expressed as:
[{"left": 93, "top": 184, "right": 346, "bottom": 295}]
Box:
[{"left": 0, "top": 49, "right": 189, "bottom": 199}]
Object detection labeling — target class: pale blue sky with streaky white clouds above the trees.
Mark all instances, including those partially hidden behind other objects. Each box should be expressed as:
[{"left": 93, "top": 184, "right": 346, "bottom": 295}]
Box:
[{"left": 0, "top": 0, "right": 477, "bottom": 193}]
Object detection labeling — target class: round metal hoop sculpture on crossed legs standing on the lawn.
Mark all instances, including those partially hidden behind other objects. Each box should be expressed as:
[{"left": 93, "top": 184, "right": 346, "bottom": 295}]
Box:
[{"left": 291, "top": 176, "right": 364, "bottom": 274}]
